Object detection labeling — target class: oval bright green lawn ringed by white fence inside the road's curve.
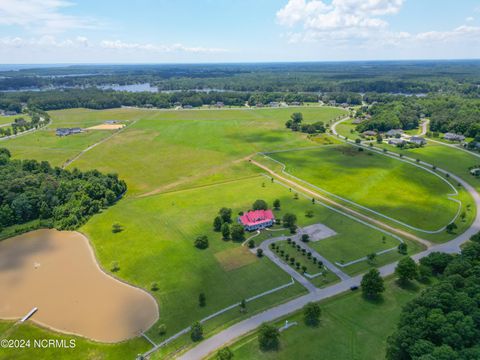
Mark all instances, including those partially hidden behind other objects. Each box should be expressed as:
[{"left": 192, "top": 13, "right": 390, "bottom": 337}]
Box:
[{"left": 269, "top": 145, "right": 458, "bottom": 230}]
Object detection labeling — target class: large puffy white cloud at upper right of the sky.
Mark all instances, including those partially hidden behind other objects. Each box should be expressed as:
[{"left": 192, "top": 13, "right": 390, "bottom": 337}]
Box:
[{"left": 276, "top": 0, "right": 480, "bottom": 48}]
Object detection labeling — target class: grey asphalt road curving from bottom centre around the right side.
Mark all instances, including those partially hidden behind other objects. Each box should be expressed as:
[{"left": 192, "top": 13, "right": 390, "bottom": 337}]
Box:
[{"left": 175, "top": 119, "right": 480, "bottom": 360}]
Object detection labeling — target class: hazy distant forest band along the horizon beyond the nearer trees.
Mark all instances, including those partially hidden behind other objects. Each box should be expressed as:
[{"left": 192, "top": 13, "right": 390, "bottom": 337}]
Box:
[{"left": 0, "top": 61, "right": 480, "bottom": 95}]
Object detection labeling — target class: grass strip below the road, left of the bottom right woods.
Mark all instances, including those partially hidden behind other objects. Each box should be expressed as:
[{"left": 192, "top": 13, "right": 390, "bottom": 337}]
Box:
[{"left": 223, "top": 279, "right": 423, "bottom": 360}]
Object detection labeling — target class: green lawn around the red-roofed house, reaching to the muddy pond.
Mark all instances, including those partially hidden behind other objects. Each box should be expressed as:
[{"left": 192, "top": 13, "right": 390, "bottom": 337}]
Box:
[{"left": 81, "top": 177, "right": 410, "bottom": 346}]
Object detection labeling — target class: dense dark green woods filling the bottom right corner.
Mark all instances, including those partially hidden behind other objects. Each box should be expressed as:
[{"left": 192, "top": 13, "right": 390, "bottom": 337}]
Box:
[{"left": 387, "top": 240, "right": 480, "bottom": 360}]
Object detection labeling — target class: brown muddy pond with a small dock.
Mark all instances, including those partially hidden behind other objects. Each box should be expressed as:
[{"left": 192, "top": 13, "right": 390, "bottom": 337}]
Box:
[{"left": 0, "top": 230, "right": 158, "bottom": 342}]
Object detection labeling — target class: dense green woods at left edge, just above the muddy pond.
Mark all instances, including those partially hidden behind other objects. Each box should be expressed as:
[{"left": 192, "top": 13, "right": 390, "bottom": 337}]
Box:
[{"left": 0, "top": 148, "right": 126, "bottom": 229}]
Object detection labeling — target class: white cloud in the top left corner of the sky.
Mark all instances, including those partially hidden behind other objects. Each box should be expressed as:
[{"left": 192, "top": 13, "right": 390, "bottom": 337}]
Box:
[{"left": 0, "top": 0, "right": 98, "bottom": 33}]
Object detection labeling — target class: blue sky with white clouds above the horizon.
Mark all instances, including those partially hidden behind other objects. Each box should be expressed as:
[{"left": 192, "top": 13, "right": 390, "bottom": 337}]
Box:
[{"left": 0, "top": 0, "right": 480, "bottom": 63}]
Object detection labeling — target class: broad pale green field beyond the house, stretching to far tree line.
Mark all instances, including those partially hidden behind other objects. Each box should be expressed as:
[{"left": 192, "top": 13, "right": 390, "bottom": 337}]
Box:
[{"left": 36, "top": 107, "right": 343, "bottom": 194}]
